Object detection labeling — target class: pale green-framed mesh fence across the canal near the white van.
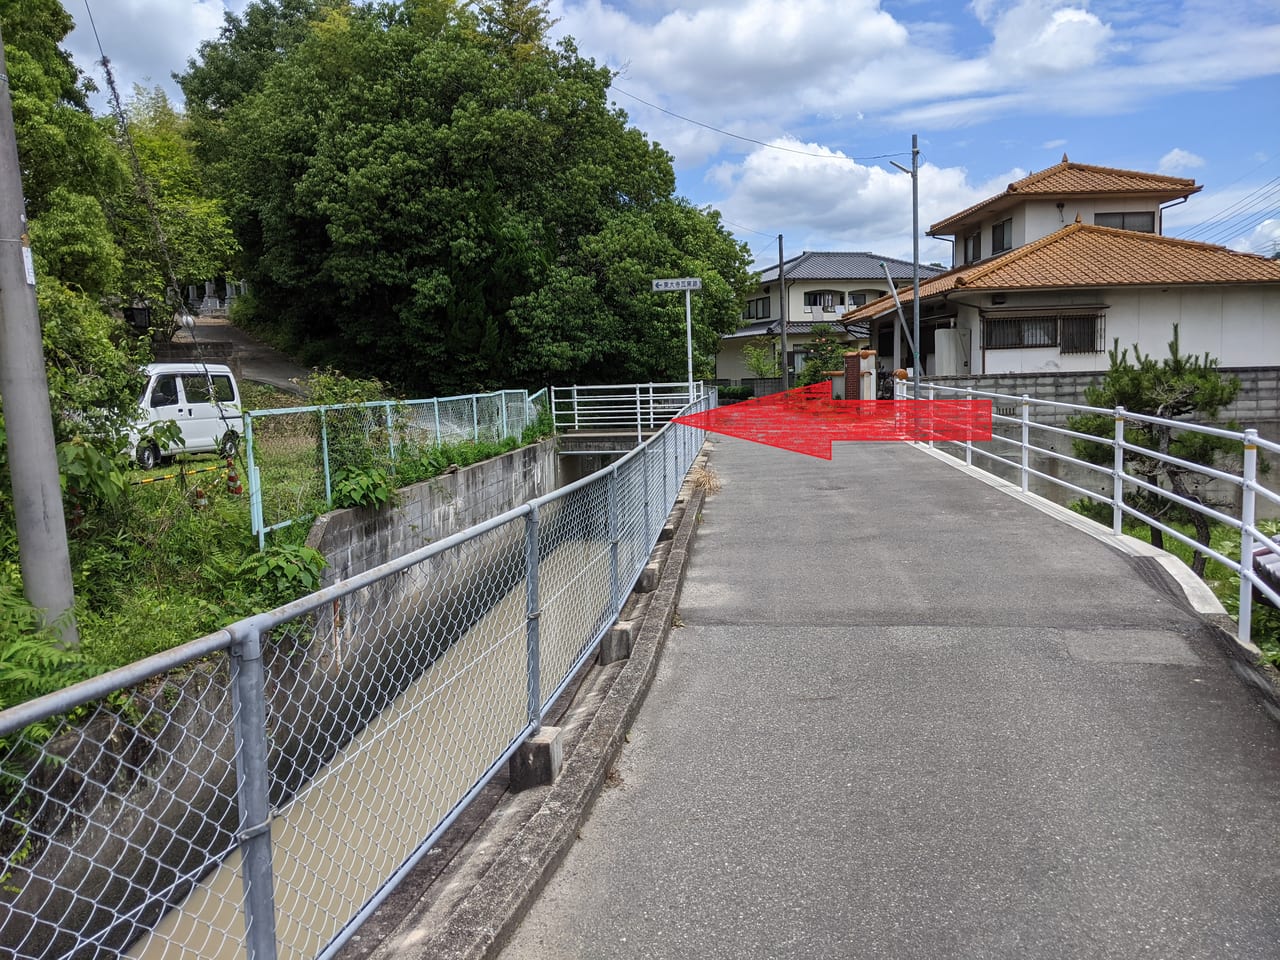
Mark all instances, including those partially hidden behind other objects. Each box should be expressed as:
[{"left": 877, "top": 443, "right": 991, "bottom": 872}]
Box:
[{"left": 244, "top": 390, "right": 548, "bottom": 544}]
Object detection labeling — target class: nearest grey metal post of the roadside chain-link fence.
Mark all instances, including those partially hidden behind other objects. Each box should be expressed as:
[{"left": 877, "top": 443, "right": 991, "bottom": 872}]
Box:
[{"left": 230, "top": 618, "right": 275, "bottom": 960}]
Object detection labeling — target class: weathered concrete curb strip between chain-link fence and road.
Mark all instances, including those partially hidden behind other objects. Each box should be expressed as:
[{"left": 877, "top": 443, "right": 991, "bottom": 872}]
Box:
[{"left": 339, "top": 451, "right": 707, "bottom": 960}]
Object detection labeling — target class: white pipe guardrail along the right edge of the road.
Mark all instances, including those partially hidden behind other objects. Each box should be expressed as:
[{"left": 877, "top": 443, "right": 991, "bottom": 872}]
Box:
[{"left": 897, "top": 384, "right": 1280, "bottom": 645}]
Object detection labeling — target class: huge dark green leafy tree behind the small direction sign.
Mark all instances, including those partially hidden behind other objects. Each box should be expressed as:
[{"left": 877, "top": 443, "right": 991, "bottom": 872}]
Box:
[{"left": 194, "top": 0, "right": 749, "bottom": 392}]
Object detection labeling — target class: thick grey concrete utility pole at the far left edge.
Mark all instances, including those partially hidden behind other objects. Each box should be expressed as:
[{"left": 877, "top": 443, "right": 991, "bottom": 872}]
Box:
[{"left": 0, "top": 28, "right": 79, "bottom": 646}]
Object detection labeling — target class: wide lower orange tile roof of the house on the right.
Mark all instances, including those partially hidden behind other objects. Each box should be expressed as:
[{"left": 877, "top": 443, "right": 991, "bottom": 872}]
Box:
[{"left": 840, "top": 221, "right": 1280, "bottom": 321}]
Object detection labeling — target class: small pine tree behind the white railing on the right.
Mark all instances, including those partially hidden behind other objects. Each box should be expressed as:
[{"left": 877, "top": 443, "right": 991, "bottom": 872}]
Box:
[{"left": 1068, "top": 324, "right": 1240, "bottom": 576}]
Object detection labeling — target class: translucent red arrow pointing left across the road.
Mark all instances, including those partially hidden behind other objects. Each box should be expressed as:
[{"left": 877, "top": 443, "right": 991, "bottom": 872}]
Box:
[{"left": 676, "top": 380, "right": 991, "bottom": 460}]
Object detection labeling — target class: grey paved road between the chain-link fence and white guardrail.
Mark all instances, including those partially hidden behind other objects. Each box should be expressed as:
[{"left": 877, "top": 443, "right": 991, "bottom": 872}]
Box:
[{"left": 502, "top": 439, "right": 1280, "bottom": 960}]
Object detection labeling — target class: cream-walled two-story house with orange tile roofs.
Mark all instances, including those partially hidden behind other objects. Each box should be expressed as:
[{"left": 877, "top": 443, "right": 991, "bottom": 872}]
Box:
[{"left": 841, "top": 156, "right": 1280, "bottom": 376}]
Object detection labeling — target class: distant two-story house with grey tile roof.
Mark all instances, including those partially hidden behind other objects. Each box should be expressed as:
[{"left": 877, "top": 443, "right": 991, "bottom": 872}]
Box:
[{"left": 716, "top": 251, "right": 942, "bottom": 381}]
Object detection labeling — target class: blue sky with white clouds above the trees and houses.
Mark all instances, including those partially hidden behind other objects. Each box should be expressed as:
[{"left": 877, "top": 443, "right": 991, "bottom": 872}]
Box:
[{"left": 63, "top": 0, "right": 1280, "bottom": 265}]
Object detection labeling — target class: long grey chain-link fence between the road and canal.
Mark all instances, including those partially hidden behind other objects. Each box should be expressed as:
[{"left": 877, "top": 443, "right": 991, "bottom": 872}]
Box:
[{"left": 0, "top": 398, "right": 714, "bottom": 960}]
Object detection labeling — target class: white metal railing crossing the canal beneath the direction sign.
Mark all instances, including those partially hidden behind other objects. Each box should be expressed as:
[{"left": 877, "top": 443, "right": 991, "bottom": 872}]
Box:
[{"left": 552, "top": 381, "right": 712, "bottom": 443}]
